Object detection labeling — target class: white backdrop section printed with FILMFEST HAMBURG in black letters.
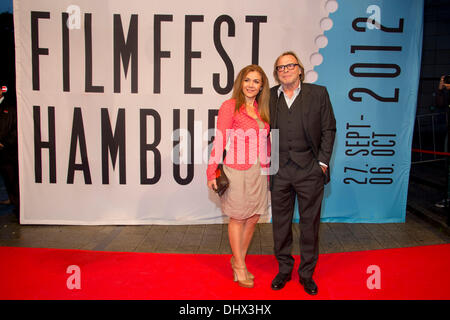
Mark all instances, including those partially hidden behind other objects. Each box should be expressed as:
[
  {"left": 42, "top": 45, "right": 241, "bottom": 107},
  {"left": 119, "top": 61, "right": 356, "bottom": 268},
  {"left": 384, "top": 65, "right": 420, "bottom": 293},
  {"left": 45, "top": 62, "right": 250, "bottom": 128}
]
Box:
[{"left": 14, "top": 0, "right": 337, "bottom": 224}]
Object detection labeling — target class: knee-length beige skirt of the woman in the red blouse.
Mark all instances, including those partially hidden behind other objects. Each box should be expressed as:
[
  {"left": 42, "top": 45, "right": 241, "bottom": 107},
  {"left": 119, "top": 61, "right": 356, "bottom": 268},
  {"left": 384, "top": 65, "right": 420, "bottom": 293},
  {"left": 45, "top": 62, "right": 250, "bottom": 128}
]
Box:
[{"left": 221, "top": 161, "right": 268, "bottom": 220}]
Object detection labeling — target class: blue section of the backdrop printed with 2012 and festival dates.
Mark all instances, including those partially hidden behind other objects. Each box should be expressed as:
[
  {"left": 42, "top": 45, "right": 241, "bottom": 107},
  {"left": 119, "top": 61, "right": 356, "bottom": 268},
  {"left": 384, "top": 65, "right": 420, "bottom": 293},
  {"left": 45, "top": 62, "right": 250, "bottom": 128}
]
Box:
[{"left": 308, "top": 0, "right": 424, "bottom": 223}]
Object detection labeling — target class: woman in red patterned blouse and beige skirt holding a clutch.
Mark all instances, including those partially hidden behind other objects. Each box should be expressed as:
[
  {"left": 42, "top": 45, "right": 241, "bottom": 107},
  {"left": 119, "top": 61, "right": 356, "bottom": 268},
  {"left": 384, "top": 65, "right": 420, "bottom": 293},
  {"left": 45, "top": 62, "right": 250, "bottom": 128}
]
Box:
[{"left": 206, "top": 65, "right": 270, "bottom": 288}]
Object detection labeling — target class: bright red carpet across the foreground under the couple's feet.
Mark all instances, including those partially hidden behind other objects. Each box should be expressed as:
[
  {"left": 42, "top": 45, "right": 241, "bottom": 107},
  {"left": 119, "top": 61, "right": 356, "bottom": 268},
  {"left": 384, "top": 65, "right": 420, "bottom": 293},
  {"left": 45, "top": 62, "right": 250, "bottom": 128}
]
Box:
[{"left": 0, "top": 244, "right": 450, "bottom": 300}]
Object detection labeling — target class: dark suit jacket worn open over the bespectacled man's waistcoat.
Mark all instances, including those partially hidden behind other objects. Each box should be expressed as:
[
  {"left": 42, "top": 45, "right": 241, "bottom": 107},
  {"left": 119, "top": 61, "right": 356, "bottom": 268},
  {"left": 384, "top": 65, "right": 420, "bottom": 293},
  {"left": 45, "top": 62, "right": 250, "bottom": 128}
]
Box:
[{"left": 270, "top": 83, "right": 336, "bottom": 183}]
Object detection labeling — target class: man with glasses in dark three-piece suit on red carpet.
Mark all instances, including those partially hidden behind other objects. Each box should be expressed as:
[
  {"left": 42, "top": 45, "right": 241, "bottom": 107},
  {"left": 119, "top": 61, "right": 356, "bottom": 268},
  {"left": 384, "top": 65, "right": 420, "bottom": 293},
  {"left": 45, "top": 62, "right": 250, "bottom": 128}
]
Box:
[{"left": 270, "top": 52, "right": 336, "bottom": 295}]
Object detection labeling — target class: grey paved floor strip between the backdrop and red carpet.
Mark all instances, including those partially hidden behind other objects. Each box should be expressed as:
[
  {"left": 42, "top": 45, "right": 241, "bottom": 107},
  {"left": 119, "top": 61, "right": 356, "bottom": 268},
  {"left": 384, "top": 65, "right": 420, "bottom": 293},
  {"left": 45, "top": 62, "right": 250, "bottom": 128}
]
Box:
[{"left": 0, "top": 212, "right": 450, "bottom": 254}]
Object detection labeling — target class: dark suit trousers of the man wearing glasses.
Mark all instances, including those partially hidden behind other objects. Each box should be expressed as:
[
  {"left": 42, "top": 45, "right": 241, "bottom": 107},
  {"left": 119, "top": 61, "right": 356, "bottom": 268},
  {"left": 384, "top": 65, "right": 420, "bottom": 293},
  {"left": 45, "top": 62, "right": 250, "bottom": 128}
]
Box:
[{"left": 271, "top": 160, "right": 324, "bottom": 278}]
